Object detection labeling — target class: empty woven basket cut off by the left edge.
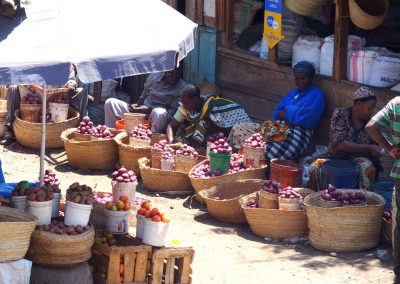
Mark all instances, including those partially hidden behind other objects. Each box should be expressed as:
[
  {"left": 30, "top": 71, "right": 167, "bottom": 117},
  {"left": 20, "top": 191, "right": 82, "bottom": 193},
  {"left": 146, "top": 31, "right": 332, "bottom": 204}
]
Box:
[{"left": 0, "top": 206, "right": 37, "bottom": 262}]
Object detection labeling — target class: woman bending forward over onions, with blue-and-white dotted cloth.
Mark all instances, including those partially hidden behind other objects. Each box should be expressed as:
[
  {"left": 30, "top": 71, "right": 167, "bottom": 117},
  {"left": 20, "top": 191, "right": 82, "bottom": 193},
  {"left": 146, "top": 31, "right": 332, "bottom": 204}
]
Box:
[{"left": 167, "top": 84, "right": 251, "bottom": 146}]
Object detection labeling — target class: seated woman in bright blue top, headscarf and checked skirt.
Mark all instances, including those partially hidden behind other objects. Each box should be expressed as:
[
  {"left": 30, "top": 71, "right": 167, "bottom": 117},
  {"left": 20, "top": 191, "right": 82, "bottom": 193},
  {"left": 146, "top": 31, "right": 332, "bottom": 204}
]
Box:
[{"left": 229, "top": 61, "right": 326, "bottom": 160}]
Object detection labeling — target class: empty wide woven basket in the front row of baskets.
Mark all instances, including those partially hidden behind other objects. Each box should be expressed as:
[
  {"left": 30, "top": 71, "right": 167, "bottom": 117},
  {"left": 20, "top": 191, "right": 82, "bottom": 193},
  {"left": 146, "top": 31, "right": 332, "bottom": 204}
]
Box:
[{"left": 199, "top": 179, "right": 264, "bottom": 223}]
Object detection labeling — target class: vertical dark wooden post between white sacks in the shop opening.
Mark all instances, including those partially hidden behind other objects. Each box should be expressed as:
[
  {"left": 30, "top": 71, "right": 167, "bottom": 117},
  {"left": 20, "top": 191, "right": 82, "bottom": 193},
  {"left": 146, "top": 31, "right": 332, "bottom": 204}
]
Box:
[{"left": 333, "top": 0, "right": 349, "bottom": 82}]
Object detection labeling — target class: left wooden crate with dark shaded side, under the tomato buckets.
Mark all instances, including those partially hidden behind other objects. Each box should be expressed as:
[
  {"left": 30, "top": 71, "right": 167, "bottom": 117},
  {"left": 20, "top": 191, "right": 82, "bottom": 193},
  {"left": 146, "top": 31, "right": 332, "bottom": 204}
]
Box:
[{"left": 91, "top": 235, "right": 152, "bottom": 284}]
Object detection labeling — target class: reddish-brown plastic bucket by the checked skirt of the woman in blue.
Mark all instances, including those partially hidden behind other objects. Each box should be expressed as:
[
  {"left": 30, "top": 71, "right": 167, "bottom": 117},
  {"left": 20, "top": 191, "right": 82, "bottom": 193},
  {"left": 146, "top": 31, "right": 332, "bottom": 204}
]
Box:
[{"left": 269, "top": 159, "right": 303, "bottom": 187}]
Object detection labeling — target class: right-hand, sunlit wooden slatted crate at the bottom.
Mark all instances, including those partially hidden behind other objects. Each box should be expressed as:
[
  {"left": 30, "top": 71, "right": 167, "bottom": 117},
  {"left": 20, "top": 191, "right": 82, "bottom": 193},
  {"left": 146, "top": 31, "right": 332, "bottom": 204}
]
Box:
[{"left": 149, "top": 248, "right": 194, "bottom": 284}]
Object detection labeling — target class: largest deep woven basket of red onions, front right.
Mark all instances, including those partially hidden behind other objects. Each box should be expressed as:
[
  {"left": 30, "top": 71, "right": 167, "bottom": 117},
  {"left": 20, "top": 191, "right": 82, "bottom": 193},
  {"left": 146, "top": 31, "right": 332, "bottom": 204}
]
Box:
[{"left": 304, "top": 190, "right": 385, "bottom": 252}]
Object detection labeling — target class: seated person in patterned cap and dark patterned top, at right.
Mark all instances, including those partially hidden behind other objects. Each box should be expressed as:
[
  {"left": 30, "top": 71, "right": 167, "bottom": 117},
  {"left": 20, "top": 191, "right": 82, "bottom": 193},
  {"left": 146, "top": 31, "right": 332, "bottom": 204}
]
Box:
[{"left": 308, "top": 87, "right": 382, "bottom": 191}]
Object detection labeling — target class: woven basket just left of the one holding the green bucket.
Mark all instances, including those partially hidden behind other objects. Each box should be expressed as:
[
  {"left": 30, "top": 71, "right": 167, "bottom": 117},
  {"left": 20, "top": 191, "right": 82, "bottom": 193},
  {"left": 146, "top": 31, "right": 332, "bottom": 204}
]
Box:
[{"left": 139, "top": 158, "right": 193, "bottom": 194}]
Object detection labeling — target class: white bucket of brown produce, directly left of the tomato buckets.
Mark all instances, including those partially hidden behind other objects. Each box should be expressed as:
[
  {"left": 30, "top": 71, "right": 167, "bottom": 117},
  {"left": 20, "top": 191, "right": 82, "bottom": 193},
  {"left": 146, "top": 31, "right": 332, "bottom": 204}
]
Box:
[{"left": 64, "top": 200, "right": 93, "bottom": 227}]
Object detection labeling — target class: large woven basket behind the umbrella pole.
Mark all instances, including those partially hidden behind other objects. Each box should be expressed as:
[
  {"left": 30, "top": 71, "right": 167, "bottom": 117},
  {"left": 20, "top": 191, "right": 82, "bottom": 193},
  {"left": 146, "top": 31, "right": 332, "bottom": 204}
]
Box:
[{"left": 13, "top": 107, "right": 79, "bottom": 149}]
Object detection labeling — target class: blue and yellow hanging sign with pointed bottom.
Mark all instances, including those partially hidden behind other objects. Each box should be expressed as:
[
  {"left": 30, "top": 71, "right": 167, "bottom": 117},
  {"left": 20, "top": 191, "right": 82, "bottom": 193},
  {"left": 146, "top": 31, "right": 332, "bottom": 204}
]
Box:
[{"left": 264, "top": 0, "right": 284, "bottom": 48}]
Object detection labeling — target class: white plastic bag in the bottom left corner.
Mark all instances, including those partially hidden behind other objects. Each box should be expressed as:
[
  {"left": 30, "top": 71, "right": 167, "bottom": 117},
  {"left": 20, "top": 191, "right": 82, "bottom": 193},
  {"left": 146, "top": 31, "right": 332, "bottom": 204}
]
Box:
[{"left": 0, "top": 259, "right": 32, "bottom": 284}]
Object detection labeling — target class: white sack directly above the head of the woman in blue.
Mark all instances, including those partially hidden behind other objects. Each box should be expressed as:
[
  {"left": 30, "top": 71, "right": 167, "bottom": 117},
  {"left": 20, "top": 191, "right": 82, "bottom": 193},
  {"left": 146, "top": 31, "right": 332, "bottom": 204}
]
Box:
[{"left": 292, "top": 36, "right": 322, "bottom": 73}]
